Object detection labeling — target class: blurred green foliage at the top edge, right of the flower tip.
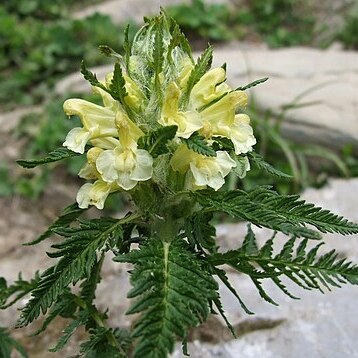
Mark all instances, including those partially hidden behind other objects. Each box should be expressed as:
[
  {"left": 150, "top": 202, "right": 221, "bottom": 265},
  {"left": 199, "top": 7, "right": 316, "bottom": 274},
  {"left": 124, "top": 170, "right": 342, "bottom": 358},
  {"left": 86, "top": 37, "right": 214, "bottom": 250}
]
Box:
[{"left": 168, "top": 0, "right": 315, "bottom": 47}]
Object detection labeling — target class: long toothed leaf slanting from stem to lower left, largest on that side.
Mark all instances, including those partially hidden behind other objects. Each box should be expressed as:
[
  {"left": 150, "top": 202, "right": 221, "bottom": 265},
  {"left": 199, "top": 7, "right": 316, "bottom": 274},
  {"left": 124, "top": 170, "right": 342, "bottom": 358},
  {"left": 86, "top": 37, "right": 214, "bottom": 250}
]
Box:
[{"left": 18, "top": 214, "right": 138, "bottom": 327}]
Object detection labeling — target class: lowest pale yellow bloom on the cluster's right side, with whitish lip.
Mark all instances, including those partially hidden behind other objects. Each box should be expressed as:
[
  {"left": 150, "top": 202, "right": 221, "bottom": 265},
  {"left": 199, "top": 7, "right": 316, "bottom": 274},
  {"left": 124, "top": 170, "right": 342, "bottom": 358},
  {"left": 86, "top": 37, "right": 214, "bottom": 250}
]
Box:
[{"left": 171, "top": 144, "right": 236, "bottom": 190}]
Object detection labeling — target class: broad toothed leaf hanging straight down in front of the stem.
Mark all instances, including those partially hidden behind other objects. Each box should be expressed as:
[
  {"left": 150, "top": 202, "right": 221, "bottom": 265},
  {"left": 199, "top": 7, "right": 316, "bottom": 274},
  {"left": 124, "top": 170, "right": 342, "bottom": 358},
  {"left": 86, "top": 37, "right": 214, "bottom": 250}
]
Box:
[{"left": 115, "top": 238, "right": 218, "bottom": 358}]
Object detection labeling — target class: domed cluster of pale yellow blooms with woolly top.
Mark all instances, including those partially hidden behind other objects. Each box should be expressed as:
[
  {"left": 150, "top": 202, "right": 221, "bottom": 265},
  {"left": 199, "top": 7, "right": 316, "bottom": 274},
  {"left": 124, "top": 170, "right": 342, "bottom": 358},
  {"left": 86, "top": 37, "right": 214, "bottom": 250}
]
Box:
[{"left": 63, "top": 14, "right": 256, "bottom": 209}]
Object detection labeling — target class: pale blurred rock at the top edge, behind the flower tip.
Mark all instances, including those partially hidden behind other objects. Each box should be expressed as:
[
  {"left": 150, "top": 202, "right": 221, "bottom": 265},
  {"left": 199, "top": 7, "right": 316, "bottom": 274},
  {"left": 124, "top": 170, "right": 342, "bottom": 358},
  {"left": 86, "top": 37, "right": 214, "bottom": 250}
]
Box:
[{"left": 73, "top": 0, "right": 231, "bottom": 24}]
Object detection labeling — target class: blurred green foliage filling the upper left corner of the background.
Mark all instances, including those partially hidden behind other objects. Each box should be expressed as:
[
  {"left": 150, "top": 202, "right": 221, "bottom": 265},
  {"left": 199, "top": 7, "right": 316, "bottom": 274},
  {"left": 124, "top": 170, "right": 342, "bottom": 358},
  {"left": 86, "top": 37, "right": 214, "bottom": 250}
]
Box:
[{"left": 0, "top": 6, "right": 136, "bottom": 109}]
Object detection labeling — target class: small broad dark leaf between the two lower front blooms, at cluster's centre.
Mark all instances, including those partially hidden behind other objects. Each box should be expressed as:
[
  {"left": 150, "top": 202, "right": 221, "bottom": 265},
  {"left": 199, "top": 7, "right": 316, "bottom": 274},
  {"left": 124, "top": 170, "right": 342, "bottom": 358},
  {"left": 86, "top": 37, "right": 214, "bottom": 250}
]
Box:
[{"left": 138, "top": 126, "right": 178, "bottom": 158}]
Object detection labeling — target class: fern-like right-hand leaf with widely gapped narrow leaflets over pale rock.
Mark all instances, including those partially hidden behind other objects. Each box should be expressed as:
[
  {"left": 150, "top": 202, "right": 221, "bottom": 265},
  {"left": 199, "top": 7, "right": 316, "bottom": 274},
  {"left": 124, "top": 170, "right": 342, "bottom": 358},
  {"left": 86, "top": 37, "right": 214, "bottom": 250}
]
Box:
[{"left": 209, "top": 228, "right": 358, "bottom": 304}]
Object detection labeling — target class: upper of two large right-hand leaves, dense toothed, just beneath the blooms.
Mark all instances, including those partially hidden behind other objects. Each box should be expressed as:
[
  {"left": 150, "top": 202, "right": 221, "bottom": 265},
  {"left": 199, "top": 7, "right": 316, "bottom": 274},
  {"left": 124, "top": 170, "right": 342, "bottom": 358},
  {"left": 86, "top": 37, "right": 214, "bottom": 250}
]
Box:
[{"left": 192, "top": 187, "right": 358, "bottom": 239}]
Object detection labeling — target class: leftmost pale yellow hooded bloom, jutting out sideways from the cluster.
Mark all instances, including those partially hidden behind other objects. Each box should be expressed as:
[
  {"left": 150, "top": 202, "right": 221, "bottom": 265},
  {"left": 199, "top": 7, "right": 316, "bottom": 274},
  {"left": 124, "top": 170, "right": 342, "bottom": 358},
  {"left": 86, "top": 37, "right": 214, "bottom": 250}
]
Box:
[{"left": 63, "top": 98, "right": 117, "bottom": 154}]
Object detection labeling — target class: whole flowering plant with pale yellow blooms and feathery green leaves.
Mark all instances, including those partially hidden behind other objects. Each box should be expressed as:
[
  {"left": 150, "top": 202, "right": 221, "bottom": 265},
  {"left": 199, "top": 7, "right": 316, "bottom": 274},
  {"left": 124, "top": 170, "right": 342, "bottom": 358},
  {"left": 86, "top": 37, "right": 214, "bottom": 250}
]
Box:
[{"left": 0, "top": 12, "right": 358, "bottom": 358}]
